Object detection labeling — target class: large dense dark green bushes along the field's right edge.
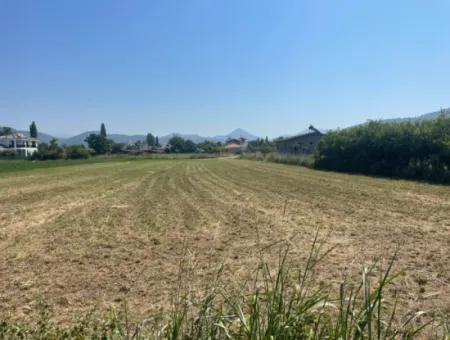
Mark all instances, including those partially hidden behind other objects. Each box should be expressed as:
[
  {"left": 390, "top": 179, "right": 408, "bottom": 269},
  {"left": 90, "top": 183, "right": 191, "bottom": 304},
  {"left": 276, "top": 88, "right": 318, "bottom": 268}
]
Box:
[{"left": 315, "top": 116, "right": 450, "bottom": 183}]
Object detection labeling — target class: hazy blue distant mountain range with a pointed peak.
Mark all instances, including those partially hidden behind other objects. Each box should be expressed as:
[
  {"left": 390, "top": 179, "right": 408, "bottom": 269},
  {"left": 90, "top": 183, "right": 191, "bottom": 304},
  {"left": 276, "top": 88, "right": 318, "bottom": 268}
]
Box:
[{"left": 14, "top": 129, "right": 258, "bottom": 145}]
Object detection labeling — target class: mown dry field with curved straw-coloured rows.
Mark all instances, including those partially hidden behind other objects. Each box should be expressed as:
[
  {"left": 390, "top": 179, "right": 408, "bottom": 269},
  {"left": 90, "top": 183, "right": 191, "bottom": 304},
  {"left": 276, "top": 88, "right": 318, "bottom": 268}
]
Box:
[{"left": 0, "top": 159, "right": 450, "bottom": 323}]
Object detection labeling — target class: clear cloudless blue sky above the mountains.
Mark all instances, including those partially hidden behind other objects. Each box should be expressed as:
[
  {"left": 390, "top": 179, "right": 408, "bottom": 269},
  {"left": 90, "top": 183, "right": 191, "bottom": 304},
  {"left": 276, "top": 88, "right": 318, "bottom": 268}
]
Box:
[{"left": 0, "top": 0, "right": 450, "bottom": 137}]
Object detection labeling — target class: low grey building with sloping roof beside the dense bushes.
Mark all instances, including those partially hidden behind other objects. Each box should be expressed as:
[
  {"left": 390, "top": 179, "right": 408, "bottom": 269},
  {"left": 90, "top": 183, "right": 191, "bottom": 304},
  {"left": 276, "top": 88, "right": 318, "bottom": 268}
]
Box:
[{"left": 275, "top": 125, "right": 325, "bottom": 154}]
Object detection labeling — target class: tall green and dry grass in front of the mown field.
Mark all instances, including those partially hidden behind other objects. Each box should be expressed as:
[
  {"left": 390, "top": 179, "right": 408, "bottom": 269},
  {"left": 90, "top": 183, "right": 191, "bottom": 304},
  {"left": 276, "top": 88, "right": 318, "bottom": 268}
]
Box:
[{"left": 0, "top": 237, "right": 449, "bottom": 340}]
